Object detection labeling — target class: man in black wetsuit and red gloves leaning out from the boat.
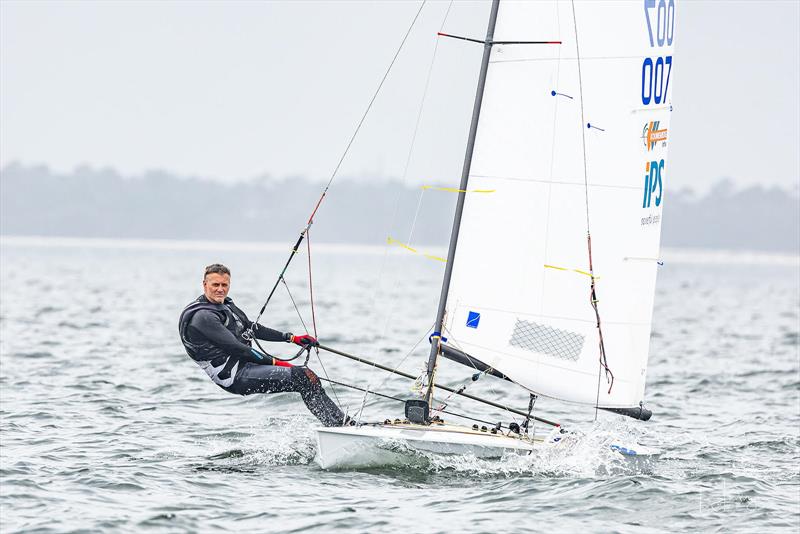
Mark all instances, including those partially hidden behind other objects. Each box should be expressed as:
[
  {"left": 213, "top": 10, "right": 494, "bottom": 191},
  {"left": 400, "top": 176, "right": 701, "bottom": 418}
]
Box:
[{"left": 178, "top": 263, "right": 344, "bottom": 426}]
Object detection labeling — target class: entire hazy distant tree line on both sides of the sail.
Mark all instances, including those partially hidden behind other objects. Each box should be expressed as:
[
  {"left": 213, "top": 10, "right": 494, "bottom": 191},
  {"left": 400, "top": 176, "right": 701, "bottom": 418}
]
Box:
[{"left": 0, "top": 164, "right": 800, "bottom": 252}]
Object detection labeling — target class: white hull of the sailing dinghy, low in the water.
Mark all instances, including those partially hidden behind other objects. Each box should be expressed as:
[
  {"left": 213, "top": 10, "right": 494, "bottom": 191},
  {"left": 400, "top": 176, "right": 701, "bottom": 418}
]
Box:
[{"left": 316, "top": 424, "right": 541, "bottom": 469}]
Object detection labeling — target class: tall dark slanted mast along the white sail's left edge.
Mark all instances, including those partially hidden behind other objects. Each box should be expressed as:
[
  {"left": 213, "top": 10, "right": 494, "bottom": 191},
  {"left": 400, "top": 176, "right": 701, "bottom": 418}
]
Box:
[{"left": 425, "top": 0, "right": 500, "bottom": 412}]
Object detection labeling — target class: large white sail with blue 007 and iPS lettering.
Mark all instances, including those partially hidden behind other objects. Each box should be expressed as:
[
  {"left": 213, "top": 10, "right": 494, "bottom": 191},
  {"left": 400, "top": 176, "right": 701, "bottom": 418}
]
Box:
[{"left": 445, "top": 0, "right": 676, "bottom": 408}]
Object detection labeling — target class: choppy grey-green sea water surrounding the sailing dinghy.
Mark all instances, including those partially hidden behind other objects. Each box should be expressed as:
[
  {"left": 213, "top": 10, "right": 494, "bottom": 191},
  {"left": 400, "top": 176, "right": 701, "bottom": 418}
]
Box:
[{"left": 0, "top": 239, "right": 800, "bottom": 532}]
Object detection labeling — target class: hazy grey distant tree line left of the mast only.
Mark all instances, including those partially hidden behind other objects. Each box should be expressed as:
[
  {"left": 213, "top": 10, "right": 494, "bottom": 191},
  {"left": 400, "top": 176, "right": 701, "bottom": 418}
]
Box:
[{"left": 0, "top": 164, "right": 455, "bottom": 244}]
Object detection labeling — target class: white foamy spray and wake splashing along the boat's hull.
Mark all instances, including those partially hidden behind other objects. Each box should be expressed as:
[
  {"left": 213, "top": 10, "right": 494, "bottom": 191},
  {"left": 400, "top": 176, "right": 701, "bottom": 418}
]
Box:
[{"left": 180, "top": 415, "right": 658, "bottom": 478}]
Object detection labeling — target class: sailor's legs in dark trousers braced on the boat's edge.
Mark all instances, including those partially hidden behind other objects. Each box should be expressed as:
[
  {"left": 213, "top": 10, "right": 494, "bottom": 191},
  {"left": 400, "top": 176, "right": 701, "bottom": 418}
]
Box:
[{"left": 225, "top": 363, "right": 344, "bottom": 426}]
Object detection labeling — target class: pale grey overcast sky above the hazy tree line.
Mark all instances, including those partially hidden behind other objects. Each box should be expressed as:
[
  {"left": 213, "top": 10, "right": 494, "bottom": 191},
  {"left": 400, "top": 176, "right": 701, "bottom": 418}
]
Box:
[{"left": 0, "top": 0, "right": 800, "bottom": 191}]
